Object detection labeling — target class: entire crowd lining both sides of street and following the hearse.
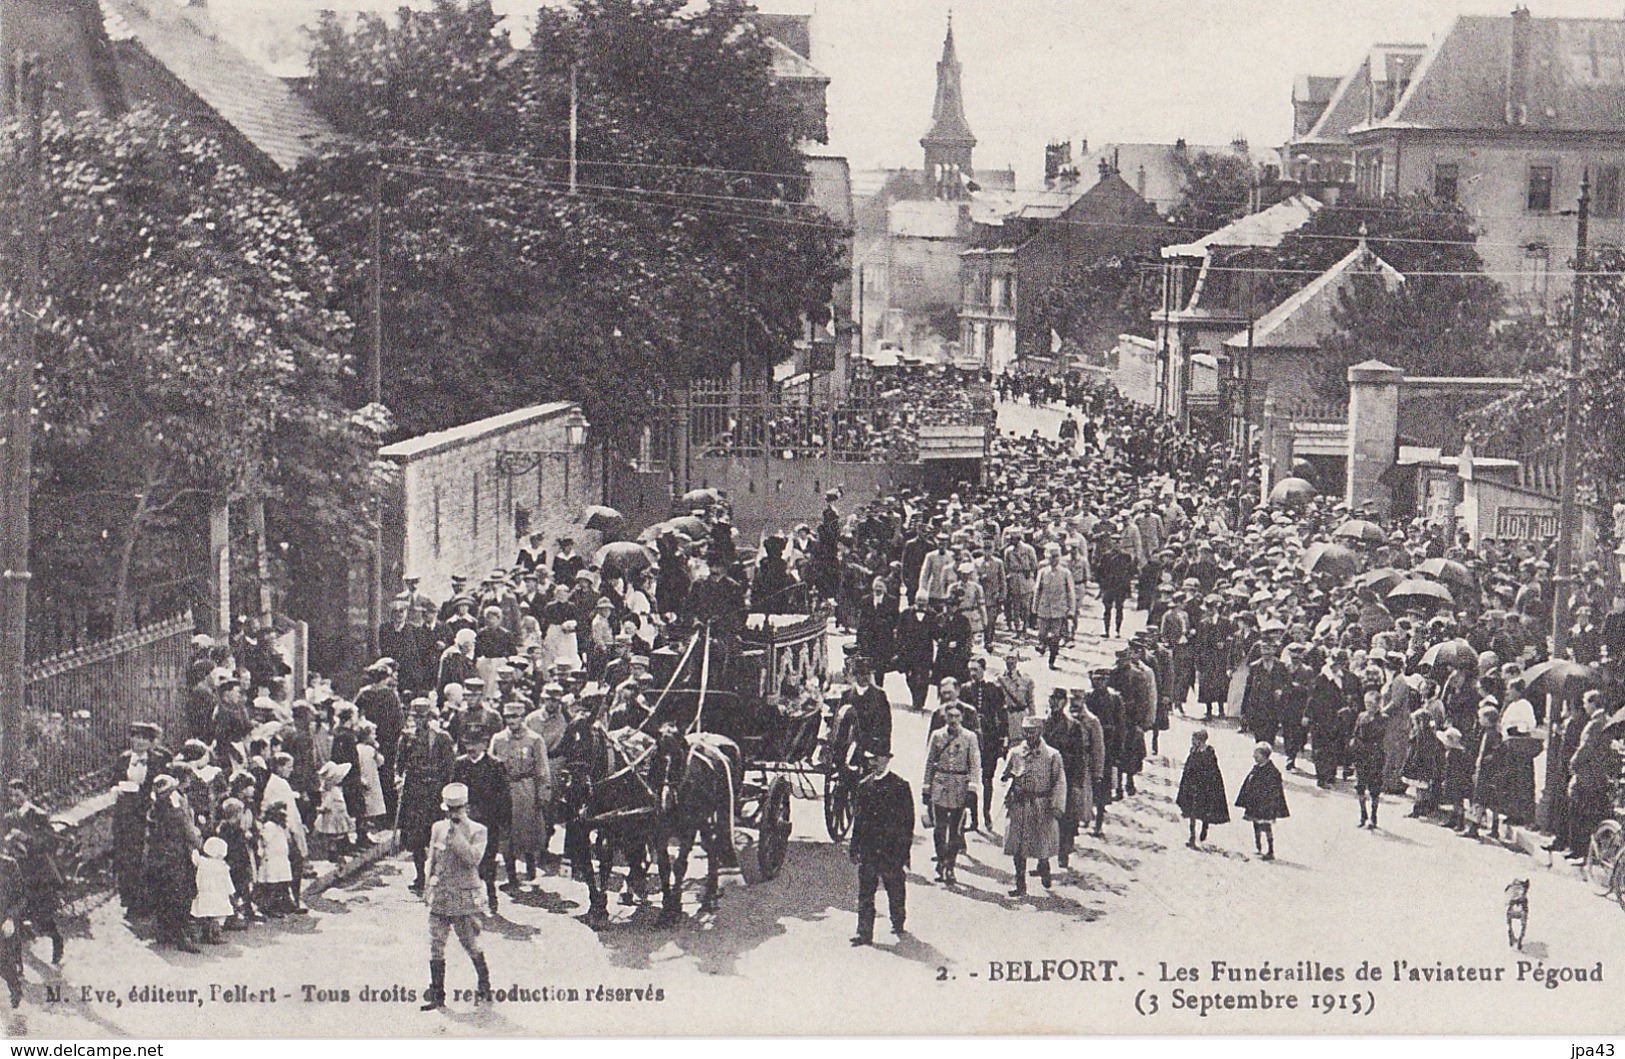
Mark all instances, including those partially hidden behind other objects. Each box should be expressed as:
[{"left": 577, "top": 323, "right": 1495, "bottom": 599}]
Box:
[{"left": 0, "top": 363, "right": 1625, "bottom": 997}]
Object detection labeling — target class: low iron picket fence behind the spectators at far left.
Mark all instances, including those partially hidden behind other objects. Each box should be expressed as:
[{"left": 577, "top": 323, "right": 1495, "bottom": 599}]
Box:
[{"left": 20, "top": 612, "right": 193, "bottom": 804}]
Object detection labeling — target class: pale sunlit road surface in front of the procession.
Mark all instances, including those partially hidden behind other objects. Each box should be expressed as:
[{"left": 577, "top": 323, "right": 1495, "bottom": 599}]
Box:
[{"left": 10, "top": 401, "right": 1625, "bottom": 1038}]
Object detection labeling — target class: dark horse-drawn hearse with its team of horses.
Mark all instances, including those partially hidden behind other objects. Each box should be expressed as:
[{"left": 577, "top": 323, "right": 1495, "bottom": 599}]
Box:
[{"left": 559, "top": 609, "right": 858, "bottom": 924}]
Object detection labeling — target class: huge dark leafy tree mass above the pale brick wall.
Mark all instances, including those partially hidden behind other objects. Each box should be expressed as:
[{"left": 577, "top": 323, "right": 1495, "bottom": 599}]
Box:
[{"left": 297, "top": 0, "right": 840, "bottom": 439}]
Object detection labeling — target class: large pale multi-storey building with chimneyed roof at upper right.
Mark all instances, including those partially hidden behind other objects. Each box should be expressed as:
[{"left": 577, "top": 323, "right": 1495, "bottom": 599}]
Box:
[{"left": 1349, "top": 6, "right": 1625, "bottom": 313}]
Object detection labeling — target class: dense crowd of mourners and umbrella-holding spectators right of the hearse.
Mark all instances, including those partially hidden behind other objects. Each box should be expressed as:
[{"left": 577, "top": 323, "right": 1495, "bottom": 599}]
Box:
[{"left": 825, "top": 378, "right": 1625, "bottom": 940}]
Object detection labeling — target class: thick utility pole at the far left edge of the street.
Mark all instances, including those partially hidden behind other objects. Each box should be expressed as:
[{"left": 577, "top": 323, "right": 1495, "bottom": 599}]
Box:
[{"left": 0, "top": 54, "right": 46, "bottom": 783}]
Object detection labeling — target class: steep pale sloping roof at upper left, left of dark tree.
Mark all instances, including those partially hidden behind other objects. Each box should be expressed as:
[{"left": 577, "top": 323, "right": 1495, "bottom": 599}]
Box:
[{"left": 102, "top": 0, "right": 338, "bottom": 171}]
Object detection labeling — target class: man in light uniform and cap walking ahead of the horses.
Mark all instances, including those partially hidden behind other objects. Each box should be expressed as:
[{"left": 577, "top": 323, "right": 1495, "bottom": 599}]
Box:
[{"left": 423, "top": 783, "right": 491, "bottom": 1012}]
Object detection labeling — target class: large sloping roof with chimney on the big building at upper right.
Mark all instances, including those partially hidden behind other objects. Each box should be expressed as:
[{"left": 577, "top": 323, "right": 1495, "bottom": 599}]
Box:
[{"left": 1372, "top": 15, "right": 1625, "bottom": 132}]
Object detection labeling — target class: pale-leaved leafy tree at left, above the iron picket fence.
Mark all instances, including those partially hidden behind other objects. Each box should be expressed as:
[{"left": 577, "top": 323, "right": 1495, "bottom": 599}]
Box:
[{"left": 0, "top": 112, "right": 387, "bottom": 629}]
